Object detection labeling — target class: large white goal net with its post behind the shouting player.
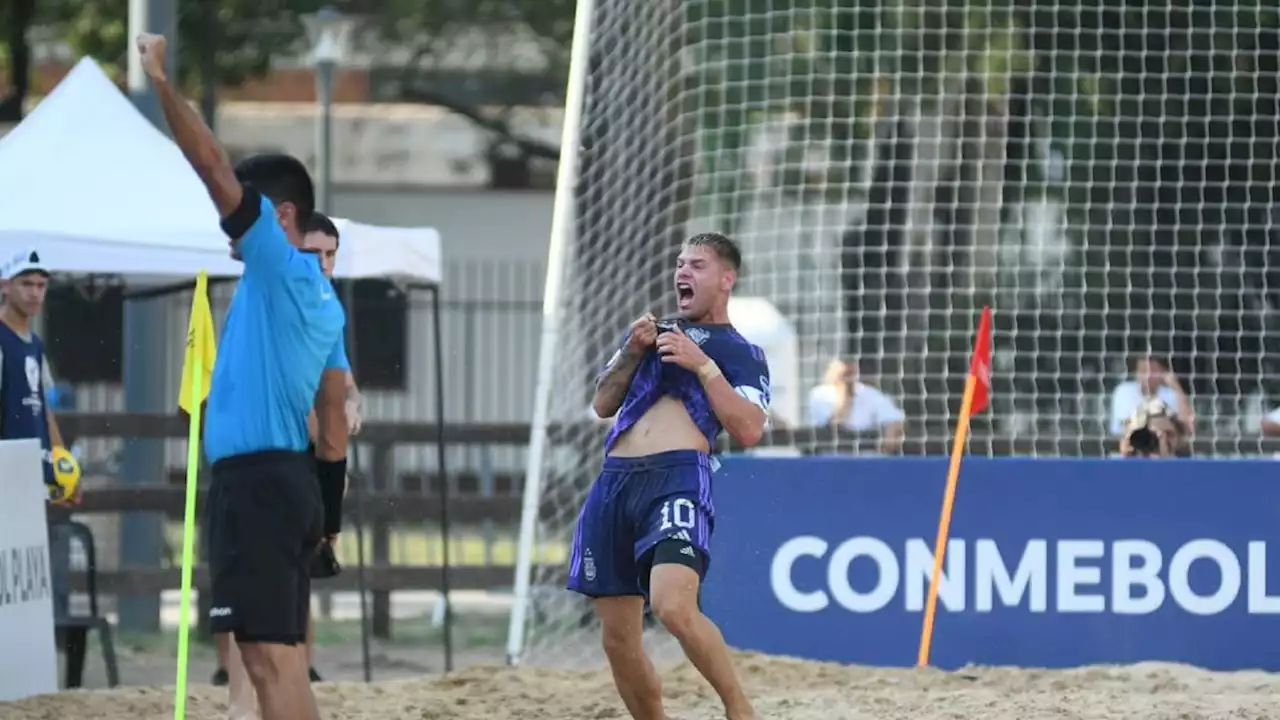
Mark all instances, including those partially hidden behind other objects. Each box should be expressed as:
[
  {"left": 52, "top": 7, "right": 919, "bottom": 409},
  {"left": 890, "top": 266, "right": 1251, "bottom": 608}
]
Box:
[{"left": 511, "top": 0, "right": 1280, "bottom": 662}]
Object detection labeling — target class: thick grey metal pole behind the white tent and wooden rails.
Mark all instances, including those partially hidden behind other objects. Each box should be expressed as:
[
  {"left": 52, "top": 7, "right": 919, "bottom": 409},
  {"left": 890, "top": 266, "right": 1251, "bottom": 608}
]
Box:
[{"left": 119, "top": 0, "right": 178, "bottom": 633}]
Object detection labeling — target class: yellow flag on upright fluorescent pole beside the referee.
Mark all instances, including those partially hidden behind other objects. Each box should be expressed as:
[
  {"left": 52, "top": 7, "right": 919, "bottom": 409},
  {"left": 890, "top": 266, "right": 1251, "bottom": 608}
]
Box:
[{"left": 173, "top": 270, "right": 216, "bottom": 720}]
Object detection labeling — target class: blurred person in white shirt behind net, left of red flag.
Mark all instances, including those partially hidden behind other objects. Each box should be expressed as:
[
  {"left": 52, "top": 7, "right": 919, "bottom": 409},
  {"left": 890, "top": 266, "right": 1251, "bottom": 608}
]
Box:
[{"left": 809, "top": 359, "right": 906, "bottom": 452}]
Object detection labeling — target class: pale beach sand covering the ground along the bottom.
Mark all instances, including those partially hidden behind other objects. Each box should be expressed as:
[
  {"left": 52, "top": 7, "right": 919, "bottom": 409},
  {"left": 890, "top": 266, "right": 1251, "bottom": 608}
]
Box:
[{"left": 0, "top": 653, "right": 1280, "bottom": 720}]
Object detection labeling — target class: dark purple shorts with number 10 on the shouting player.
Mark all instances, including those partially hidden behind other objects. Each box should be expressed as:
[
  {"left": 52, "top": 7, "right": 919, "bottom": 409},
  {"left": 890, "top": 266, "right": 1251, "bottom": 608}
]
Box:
[{"left": 567, "top": 450, "right": 716, "bottom": 597}]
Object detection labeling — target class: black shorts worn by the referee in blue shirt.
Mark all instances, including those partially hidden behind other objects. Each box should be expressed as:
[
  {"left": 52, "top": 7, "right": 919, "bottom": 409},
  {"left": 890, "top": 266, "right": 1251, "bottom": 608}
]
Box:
[{"left": 205, "top": 451, "right": 324, "bottom": 644}]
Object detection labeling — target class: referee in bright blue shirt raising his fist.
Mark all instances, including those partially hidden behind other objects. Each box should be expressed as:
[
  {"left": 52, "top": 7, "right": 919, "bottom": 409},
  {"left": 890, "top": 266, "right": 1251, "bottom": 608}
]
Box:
[{"left": 137, "top": 33, "right": 349, "bottom": 720}]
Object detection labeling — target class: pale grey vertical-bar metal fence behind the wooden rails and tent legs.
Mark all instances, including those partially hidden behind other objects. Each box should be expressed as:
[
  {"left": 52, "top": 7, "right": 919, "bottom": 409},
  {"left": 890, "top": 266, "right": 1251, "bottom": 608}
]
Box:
[{"left": 63, "top": 260, "right": 544, "bottom": 473}]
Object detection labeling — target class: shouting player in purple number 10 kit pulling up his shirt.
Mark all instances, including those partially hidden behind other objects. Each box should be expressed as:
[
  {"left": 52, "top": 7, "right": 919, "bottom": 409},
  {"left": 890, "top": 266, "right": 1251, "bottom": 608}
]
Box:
[{"left": 568, "top": 233, "right": 769, "bottom": 720}]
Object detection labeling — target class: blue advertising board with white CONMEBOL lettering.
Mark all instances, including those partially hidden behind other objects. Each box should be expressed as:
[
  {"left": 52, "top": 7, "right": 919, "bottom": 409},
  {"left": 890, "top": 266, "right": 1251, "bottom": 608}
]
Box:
[{"left": 703, "top": 456, "right": 1280, "bottom": 670}]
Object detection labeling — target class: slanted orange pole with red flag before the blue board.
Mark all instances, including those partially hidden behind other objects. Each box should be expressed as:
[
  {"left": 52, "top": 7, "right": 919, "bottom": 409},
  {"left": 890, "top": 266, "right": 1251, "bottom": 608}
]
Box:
[{"left": 915, "top": 307, "right": 991, "bottom": 667}]
